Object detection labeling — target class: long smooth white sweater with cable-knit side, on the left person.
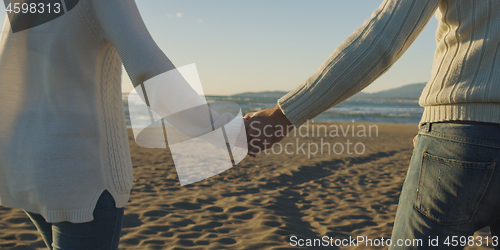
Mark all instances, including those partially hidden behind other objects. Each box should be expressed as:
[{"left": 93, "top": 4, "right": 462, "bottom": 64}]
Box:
[{"left": 0, "top": 0, "right": 174, "bottom": 223}]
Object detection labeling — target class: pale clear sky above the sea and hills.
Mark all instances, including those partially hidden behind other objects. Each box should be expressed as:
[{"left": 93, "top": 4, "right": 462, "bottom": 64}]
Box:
[{"left": 0, "top": 0, "right": 437, "bottom": 95}]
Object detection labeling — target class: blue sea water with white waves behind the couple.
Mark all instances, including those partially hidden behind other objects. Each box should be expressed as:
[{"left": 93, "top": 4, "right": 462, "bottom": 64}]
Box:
[{"left": 123, "top": 94, "right": 424, "bottom": 126}]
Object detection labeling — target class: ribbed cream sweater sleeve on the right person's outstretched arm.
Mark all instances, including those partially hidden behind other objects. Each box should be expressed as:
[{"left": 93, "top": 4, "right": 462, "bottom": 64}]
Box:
[{"left": 278, "top": 0, "right": 440, "bottom": 126}]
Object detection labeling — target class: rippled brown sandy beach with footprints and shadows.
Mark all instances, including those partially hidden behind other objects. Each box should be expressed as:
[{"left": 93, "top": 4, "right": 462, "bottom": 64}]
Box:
[{"left": 0, "top": 123, "right": 489, "bottom": 250}]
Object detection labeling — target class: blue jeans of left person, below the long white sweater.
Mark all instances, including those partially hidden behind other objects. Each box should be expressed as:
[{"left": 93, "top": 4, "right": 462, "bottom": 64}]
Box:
[{"left": 26, "top": 191, "right": 124, "bottom": 250}]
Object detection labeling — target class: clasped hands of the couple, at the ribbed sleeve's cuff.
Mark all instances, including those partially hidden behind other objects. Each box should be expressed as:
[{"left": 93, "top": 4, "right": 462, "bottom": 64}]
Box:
[{"left": 244, "top": 105, "right": 294, "bottom": 157}]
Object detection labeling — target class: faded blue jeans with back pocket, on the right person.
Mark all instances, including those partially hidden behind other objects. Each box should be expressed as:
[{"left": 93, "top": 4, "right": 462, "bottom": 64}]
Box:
[{"left": 390, "top": 122, "right": 500, "bottom": 249}]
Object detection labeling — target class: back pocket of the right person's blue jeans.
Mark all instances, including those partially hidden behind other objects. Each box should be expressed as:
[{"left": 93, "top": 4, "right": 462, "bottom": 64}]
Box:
[{"left": 415, "top": 151, "right": 495, "bottom": 225}]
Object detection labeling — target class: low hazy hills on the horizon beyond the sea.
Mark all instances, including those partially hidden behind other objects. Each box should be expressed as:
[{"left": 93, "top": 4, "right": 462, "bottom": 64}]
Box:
[{"left": 231, "top": 83, "right": 425, "bottom": 99}]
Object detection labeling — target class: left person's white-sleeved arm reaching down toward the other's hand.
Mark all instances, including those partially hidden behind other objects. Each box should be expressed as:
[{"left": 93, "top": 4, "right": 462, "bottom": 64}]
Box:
[{"left": 93, "top": 0, "right": 238, "bottom": 137}]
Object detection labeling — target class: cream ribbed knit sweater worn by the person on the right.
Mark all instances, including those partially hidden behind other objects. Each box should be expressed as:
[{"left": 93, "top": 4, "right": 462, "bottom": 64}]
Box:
[{"left": 278, "top": 0, "right": 500, "bottom": 125}]
